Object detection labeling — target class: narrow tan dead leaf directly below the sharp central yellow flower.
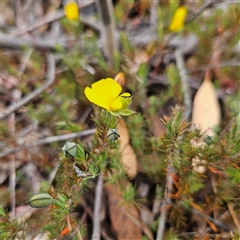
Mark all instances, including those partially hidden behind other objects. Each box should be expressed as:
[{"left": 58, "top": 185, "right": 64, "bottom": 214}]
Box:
[{"left": 117, "top": 118, "right": 138, "bottom": 178}]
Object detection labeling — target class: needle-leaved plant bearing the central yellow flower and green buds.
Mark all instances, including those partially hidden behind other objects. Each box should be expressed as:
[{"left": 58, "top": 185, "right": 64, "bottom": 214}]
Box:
[{"left": 24, "top": 78, "right": 135, "bottom": 240}]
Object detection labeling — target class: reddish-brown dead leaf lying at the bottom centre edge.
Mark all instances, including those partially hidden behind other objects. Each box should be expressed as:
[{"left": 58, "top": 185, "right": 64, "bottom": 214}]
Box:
[{"left": 106, "top": 185, "right": 142, "bottom": 240}]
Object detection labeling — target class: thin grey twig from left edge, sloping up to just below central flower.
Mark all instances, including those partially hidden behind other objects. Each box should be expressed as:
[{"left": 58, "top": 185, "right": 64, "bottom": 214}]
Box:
[{"left": 0, "top": 128, "right": 96, "bottom": 158}]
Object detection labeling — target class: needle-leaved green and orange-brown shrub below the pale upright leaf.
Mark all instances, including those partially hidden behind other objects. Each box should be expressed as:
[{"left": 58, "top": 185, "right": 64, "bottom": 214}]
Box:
[{"left": 156, "top": 107, "right": 240, "bottom": 239}]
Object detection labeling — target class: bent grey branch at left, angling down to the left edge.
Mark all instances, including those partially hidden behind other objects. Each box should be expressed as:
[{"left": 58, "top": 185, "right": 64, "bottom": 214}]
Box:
[{"left": 0, "top": 53, "right": 55, "bottom": 120}]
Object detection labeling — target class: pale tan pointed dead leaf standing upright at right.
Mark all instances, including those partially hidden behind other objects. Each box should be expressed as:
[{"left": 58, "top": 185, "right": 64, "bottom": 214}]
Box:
[{"left": 192, "top": 75, "right": 221, "bottom": 136}]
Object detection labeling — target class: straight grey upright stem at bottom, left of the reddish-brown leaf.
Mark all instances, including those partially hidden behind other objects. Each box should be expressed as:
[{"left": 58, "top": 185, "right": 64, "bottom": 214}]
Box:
[{"left": 92, "top": 173, "right": 103, "bottom": 240}]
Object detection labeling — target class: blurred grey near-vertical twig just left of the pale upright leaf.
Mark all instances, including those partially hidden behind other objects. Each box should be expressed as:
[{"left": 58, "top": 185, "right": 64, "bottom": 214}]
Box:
[{"left": 175, "top": 50, "right": 192, "bottom": 121}]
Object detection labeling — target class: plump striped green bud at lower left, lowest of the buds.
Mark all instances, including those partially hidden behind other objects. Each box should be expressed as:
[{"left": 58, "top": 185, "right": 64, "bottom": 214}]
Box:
[{"left": 25, "top": 193, "right": 54, "bottom": 208}]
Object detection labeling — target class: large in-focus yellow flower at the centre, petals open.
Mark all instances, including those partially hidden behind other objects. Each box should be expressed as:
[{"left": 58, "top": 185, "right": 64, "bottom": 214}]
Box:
[{"left": 84, "top": 78, "right": 134, "bottom": 116}]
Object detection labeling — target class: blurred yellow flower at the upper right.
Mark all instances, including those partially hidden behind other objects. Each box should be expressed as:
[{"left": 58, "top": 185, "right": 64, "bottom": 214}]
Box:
[{"left": 169, "top": 6, "right": 187, "bottom": 32}]
